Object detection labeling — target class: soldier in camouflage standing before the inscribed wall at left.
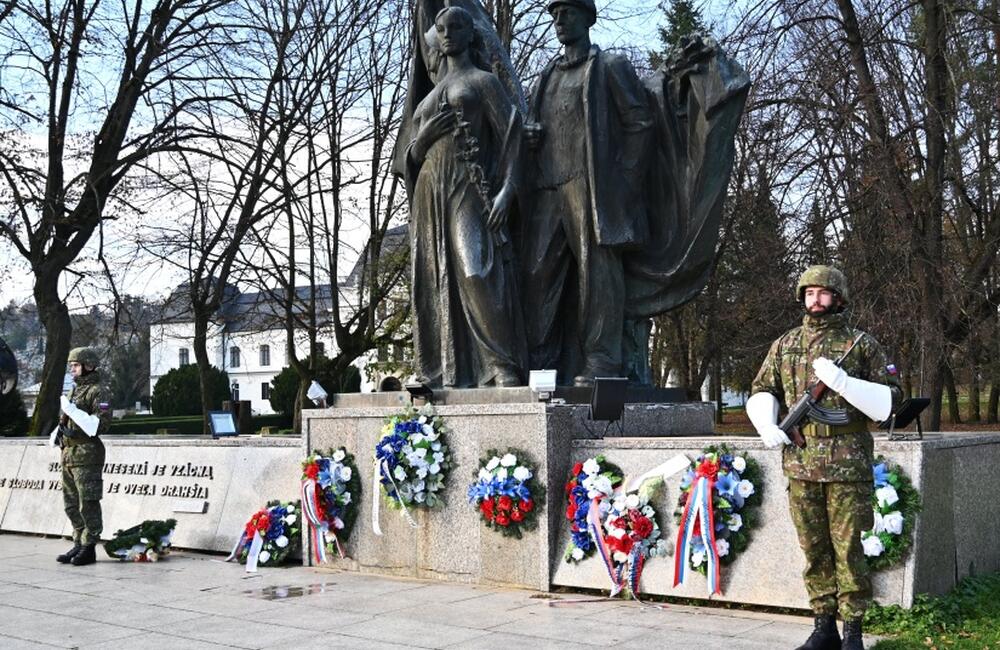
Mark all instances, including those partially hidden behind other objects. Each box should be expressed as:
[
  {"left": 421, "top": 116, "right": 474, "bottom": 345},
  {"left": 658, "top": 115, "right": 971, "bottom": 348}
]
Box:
[{"left": 56, "top": 348, "right": 111, "bottom": 566}]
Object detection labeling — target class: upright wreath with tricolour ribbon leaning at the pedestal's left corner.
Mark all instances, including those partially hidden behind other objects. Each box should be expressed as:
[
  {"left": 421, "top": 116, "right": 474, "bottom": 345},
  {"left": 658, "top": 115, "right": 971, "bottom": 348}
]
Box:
[{"left": 302, "top": 447, "right": 361, "bottom": 564}]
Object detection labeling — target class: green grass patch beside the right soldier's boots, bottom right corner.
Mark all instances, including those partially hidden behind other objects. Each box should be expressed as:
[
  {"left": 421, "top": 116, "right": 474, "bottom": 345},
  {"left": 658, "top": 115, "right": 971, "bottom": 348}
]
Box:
[{"left": 865, "top": 573, "right": 1000, "bottom": 650}]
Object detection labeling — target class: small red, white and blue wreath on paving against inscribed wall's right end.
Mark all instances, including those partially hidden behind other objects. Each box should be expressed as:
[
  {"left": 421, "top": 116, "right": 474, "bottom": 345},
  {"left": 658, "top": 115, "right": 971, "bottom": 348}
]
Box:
[{"left": 229, "top": 501, "right": 302, "bottom": 571}]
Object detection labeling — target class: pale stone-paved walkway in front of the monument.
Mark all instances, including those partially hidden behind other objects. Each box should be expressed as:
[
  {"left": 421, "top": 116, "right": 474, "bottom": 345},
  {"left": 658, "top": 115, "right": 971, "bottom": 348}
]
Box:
[{"left": 0, "top": 533, "right": 828, "bottom": 650}]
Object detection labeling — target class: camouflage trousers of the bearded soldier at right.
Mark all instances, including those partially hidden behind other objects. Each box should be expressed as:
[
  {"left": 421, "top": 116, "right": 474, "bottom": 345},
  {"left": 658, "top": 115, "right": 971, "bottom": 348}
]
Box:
[{"left": 788, "top": 478, "right": 874, "bottom": 620}]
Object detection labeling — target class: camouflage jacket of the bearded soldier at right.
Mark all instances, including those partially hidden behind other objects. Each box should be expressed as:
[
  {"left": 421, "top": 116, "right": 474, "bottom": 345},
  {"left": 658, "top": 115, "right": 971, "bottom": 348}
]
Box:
[{"left": 751, "top": 314, "right": 902, "bottom": 482}]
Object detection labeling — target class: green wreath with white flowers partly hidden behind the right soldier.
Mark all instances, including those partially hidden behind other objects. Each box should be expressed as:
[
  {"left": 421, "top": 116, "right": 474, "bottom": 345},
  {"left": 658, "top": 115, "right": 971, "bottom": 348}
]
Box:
[{"left": 861, "top": 457, "right": 920, "bottom": 571}]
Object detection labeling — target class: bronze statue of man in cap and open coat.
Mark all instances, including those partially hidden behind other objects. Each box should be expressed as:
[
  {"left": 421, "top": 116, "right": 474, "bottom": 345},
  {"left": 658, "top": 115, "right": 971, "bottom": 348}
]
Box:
[{"left": 520, "top": 0, "right": 654, "bottom": 386}]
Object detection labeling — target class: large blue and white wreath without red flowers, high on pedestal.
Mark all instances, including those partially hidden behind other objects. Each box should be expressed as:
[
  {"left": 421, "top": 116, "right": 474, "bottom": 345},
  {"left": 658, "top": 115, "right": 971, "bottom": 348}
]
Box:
[{"left": 375, "top": 407, "right": 451, "bottom": 508}]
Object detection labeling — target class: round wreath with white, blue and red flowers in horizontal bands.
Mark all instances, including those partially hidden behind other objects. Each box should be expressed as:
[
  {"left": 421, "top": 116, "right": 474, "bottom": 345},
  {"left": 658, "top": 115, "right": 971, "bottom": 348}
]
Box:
[{"left": 468, "top": 449, "right": 545, "bottom": 539}]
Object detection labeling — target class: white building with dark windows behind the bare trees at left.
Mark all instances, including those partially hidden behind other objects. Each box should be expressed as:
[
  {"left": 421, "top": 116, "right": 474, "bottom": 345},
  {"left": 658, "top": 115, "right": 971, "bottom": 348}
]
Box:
[{"left": 149, "top": 226, "right": 406, "bottom": 414}]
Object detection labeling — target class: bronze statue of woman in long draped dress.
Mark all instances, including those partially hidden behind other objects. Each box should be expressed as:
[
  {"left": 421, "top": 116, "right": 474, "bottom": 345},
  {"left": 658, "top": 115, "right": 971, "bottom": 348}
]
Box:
[{"left": 406, "top": 7, "right": 526, "bottom": 387}]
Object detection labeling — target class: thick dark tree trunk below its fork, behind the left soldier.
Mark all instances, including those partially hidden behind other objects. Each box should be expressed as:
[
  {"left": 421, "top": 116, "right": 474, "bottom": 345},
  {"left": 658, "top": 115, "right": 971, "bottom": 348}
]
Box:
[{"left": 31, "top": 269, "right": 73, "bottom": 436}]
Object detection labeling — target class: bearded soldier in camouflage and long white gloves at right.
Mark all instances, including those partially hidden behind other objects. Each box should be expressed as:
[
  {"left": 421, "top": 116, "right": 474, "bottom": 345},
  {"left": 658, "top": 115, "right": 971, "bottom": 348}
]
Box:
[{"left": 746, "top": 266, "right": 902, "bottom": 650}]
